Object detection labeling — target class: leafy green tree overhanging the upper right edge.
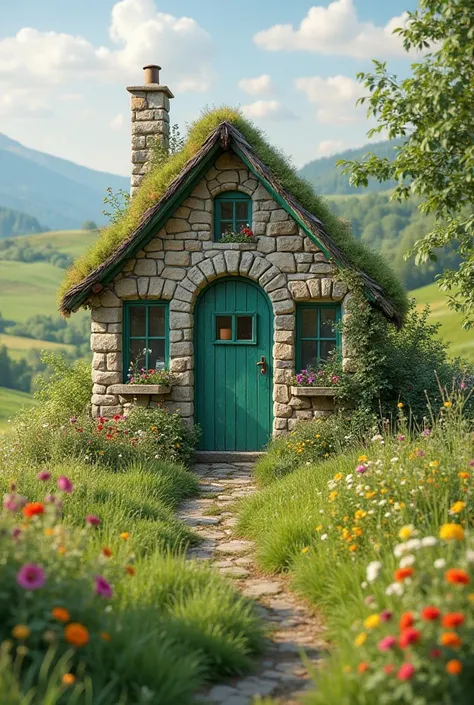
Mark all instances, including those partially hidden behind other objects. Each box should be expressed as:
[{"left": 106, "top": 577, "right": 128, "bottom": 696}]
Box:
[{"left": 339, "top": 0, "right": 474, "bottom": 327}]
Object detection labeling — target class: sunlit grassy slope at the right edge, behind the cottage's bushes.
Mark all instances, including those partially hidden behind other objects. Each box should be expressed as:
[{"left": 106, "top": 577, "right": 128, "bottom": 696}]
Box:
[{"left": 410, "top": 284, "right": 474, "bottom": 362}]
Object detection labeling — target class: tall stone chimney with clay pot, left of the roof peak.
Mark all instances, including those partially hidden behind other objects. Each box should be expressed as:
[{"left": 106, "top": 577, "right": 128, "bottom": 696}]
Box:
[{"left": 127, "top": 64, "right": 174, "bottom": 196}]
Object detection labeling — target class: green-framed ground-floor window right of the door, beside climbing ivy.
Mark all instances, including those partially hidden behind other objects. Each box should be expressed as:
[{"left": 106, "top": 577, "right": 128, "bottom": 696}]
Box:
[{"left": 296, "top": 304, "right": 341, "bottom": 372}]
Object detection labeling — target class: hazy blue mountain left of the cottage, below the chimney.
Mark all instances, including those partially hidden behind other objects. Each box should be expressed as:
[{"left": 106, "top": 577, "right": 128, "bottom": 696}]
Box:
[{"left": 0, "top": 133, "right": 130, "bottom": 230}]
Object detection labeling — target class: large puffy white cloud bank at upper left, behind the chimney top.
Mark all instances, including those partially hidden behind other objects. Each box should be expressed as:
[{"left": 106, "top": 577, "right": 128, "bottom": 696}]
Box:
[{"left": 0, "top": 0, "right": 213, "bottom": 99}]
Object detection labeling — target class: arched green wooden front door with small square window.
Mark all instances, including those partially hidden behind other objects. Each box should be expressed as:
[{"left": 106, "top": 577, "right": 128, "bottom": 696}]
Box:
[{"left": 195, "top": 277, "right": 273, "bottom": 451}]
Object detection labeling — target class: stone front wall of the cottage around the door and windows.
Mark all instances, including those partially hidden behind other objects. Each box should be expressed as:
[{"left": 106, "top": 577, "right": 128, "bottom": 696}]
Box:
[{"left": 91, "top": 152, "right": 351, "bottom": 435}]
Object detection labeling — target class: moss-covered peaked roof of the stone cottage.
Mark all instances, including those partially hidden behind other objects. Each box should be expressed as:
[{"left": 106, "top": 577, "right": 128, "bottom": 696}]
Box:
[{"left": 59, "top": 107, "right": 408, "bottom": 325}]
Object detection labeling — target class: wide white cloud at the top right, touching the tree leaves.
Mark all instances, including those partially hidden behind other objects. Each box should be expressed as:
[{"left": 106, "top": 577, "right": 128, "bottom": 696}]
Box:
[{"left": 254, "top": 0, "right": 407, "bottom": 58}]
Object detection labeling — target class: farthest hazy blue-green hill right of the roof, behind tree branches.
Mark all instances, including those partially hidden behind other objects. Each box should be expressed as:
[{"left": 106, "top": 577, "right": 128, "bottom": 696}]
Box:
[{"left": 299, "top": 140, "right": 400, "bottom": 196}]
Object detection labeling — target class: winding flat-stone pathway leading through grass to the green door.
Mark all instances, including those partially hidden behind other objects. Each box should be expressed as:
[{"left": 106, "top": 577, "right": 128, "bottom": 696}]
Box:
[{"left": 179, "top": 463, "right": 326, "bottom": 705}]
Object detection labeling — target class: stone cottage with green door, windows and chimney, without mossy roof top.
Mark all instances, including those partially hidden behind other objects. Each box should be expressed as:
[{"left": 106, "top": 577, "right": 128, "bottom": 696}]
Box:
[{"left": 61, "top": 66, "right": 397, "bottom": 451}]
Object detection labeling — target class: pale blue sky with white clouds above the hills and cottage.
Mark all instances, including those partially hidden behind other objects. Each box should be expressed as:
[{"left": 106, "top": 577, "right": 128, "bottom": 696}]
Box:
[{"left": 0, "top": 0, "right": 416, "bottom": 174}]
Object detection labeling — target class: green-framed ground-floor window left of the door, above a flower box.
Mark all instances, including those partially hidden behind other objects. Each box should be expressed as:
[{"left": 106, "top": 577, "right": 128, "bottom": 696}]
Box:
[{"left": 123, "top": 301, "right": 169, "bottom": 381}]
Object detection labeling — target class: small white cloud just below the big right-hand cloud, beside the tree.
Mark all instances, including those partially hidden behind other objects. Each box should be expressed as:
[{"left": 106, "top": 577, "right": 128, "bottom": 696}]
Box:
[{"left": 295, "top": 75, "right": 366, "bottom": 124}]
